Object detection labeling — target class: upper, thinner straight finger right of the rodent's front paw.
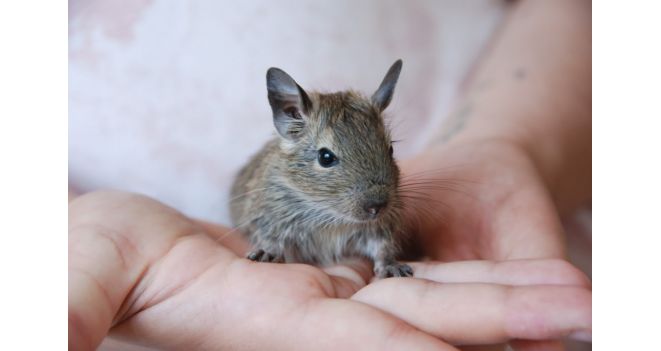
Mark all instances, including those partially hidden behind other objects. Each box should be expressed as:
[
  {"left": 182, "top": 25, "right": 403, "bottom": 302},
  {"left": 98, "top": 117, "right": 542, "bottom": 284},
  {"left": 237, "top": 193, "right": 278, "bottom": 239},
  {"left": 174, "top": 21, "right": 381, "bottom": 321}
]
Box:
[{"left": 409, "top": 259, "right": 591, "bottom": 288}]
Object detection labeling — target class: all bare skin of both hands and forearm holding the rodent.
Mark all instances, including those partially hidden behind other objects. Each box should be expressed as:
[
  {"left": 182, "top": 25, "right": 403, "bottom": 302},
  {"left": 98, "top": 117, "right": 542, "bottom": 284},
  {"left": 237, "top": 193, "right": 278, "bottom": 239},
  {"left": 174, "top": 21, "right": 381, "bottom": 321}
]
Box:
[{"left": 69, "top": 0, "right": 591, "bottom": 350}]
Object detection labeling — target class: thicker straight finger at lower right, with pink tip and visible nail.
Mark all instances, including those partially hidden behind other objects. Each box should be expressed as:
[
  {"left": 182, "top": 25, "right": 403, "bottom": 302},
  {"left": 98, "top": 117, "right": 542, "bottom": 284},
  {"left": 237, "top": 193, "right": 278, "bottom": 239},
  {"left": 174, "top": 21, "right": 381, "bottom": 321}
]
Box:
[{"left": 352, "top": 279, "right": 592, "bottom": 344}]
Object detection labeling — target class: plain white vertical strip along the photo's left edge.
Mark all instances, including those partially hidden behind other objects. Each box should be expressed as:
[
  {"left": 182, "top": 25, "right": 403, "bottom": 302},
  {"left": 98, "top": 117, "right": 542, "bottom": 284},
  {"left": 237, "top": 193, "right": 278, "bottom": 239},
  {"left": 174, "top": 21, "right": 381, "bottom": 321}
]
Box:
[{"left": 0, "top": 1, "right": 67, "bottom": 350}]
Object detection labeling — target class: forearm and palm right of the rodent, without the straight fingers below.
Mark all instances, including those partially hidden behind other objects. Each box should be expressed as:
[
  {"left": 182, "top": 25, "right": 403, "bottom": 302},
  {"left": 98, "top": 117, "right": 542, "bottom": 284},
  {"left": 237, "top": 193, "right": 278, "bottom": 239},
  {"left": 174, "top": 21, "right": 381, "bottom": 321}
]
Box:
[{"left": 396, "top": 0, "right": 592, "bottom": 349}]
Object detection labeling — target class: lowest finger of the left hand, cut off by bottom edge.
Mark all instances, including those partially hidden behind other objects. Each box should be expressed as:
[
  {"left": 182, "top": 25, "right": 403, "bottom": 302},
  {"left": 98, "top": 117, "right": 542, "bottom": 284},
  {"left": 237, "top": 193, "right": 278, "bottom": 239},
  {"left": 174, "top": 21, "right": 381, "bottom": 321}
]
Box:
[{"left": 282, "top": 299, "right": 457, "bottom": 351}]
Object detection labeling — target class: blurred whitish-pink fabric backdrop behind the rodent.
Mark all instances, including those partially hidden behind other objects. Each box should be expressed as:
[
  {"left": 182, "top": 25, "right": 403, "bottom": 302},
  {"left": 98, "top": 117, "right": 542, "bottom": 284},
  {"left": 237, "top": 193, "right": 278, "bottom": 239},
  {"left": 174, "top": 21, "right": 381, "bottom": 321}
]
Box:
[{"left": 69, "top": 0, "right": 507, "bottom": 224}]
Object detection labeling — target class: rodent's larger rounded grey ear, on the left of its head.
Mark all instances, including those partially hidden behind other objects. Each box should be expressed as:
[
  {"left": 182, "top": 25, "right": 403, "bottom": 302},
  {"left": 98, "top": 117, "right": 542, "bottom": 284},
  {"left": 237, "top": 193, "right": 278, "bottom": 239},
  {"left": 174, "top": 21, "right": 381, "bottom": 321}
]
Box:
[{"left": 266, "top": 67, "right": 312, "bottom": 141}]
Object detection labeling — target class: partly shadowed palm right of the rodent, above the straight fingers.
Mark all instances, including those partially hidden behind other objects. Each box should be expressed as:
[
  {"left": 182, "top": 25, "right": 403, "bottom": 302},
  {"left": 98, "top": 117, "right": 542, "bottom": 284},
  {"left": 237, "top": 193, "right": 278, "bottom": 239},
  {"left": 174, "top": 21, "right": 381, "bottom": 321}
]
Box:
[{"left": 403, "top": 143, "right": 563, "bottom": 260}]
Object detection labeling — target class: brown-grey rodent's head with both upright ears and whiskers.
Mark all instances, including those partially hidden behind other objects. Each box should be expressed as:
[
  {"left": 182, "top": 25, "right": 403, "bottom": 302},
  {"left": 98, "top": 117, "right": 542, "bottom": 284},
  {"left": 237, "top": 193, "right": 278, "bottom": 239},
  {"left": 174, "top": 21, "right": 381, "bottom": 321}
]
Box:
[{"left": 266, "top": 60, "right": 402, "bottom": 222}]
